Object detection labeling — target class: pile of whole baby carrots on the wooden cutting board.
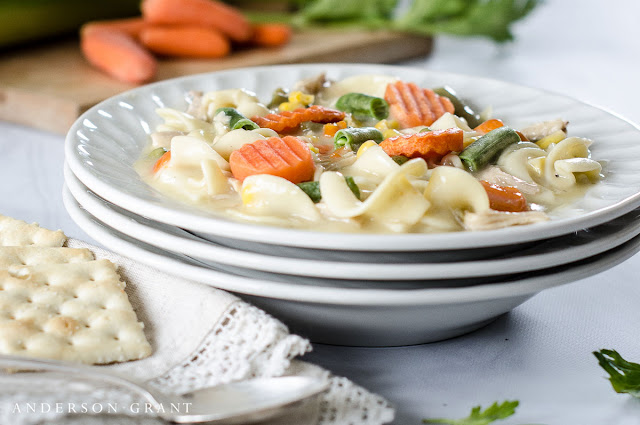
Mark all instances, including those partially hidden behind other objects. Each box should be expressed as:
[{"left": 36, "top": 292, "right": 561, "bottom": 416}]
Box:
[{"left": 80, "top": 0, "right": 291, "bottom": 84}]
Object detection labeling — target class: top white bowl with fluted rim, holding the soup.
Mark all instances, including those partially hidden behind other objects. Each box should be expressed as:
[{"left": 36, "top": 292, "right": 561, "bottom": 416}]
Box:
[{"left": 65, "top": 64, "right": 640, "bottom": 252}]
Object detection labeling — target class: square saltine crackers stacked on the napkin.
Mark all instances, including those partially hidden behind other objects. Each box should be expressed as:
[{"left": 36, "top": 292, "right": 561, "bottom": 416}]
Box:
[{"left": 0, "top": 215, "right": 151, "bottom": 364}]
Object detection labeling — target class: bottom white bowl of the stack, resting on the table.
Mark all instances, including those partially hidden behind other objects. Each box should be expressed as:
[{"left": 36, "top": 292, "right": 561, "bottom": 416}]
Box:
[{"left": 64, "top": 189, "right": 640, "bottom": 346}]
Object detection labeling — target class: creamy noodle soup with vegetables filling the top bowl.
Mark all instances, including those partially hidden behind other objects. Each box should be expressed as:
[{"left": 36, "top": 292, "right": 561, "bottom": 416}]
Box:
[{"left": 136, "top": 76, "right": 601, "bottom": 233}]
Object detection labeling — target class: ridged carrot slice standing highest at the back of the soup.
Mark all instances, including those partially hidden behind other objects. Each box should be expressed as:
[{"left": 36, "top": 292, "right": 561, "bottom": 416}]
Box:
[{"left": 384, "top": 81, "right": 455, "bottom": 127}]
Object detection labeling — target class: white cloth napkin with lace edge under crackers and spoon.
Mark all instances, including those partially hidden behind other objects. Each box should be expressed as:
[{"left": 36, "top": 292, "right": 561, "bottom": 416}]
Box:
[{"left": 0, "top": 239, "right": 394, "bottom": 425}]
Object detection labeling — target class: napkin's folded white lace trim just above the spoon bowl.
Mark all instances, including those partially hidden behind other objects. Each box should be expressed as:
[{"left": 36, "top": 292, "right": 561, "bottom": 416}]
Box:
[{"left": 148, "top": 301, "right": 311, "bottom": 394}]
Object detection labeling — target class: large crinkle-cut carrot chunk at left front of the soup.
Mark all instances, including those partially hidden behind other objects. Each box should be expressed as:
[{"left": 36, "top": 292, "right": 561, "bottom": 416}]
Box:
[{"left": 229, "top": 136, "right": 315, "bottom": 183}]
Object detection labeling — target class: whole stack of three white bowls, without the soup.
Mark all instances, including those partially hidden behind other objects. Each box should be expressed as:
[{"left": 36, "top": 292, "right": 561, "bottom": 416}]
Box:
[{"left": 64, "top": 64, "right": 640, "bottom": 346}]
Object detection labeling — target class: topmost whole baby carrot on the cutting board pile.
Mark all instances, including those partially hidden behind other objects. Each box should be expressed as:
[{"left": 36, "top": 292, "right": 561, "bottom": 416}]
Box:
[{"left": 141, "top": 0, "right": 253, "bottom": 41}]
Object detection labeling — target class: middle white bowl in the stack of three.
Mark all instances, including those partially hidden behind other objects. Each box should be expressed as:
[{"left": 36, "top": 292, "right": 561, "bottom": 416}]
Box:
[{"left": 64, "top": 167, "right": 640, "bottom": 288}]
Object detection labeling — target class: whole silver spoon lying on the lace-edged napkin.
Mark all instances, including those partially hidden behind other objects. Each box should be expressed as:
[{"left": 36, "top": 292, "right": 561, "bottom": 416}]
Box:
[{"left": 0, "top": 356, "right": 328, "bottom": 424}]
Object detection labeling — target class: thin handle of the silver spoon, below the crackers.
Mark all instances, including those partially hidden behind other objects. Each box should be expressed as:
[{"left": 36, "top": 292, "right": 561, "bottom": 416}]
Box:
[{"left": 0, "top": 355, "right": 159, "bottom": 406}]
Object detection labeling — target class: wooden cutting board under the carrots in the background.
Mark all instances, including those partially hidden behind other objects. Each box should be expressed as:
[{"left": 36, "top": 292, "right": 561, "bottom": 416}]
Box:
[{"left": 0, "top": 30, "right": 433, "bottom": 134}]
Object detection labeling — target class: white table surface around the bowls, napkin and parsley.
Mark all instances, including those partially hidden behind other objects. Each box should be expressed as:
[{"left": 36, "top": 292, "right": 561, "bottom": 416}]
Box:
[{"left": 0, "top": 0, "right": 640, "bottom": 425}]
